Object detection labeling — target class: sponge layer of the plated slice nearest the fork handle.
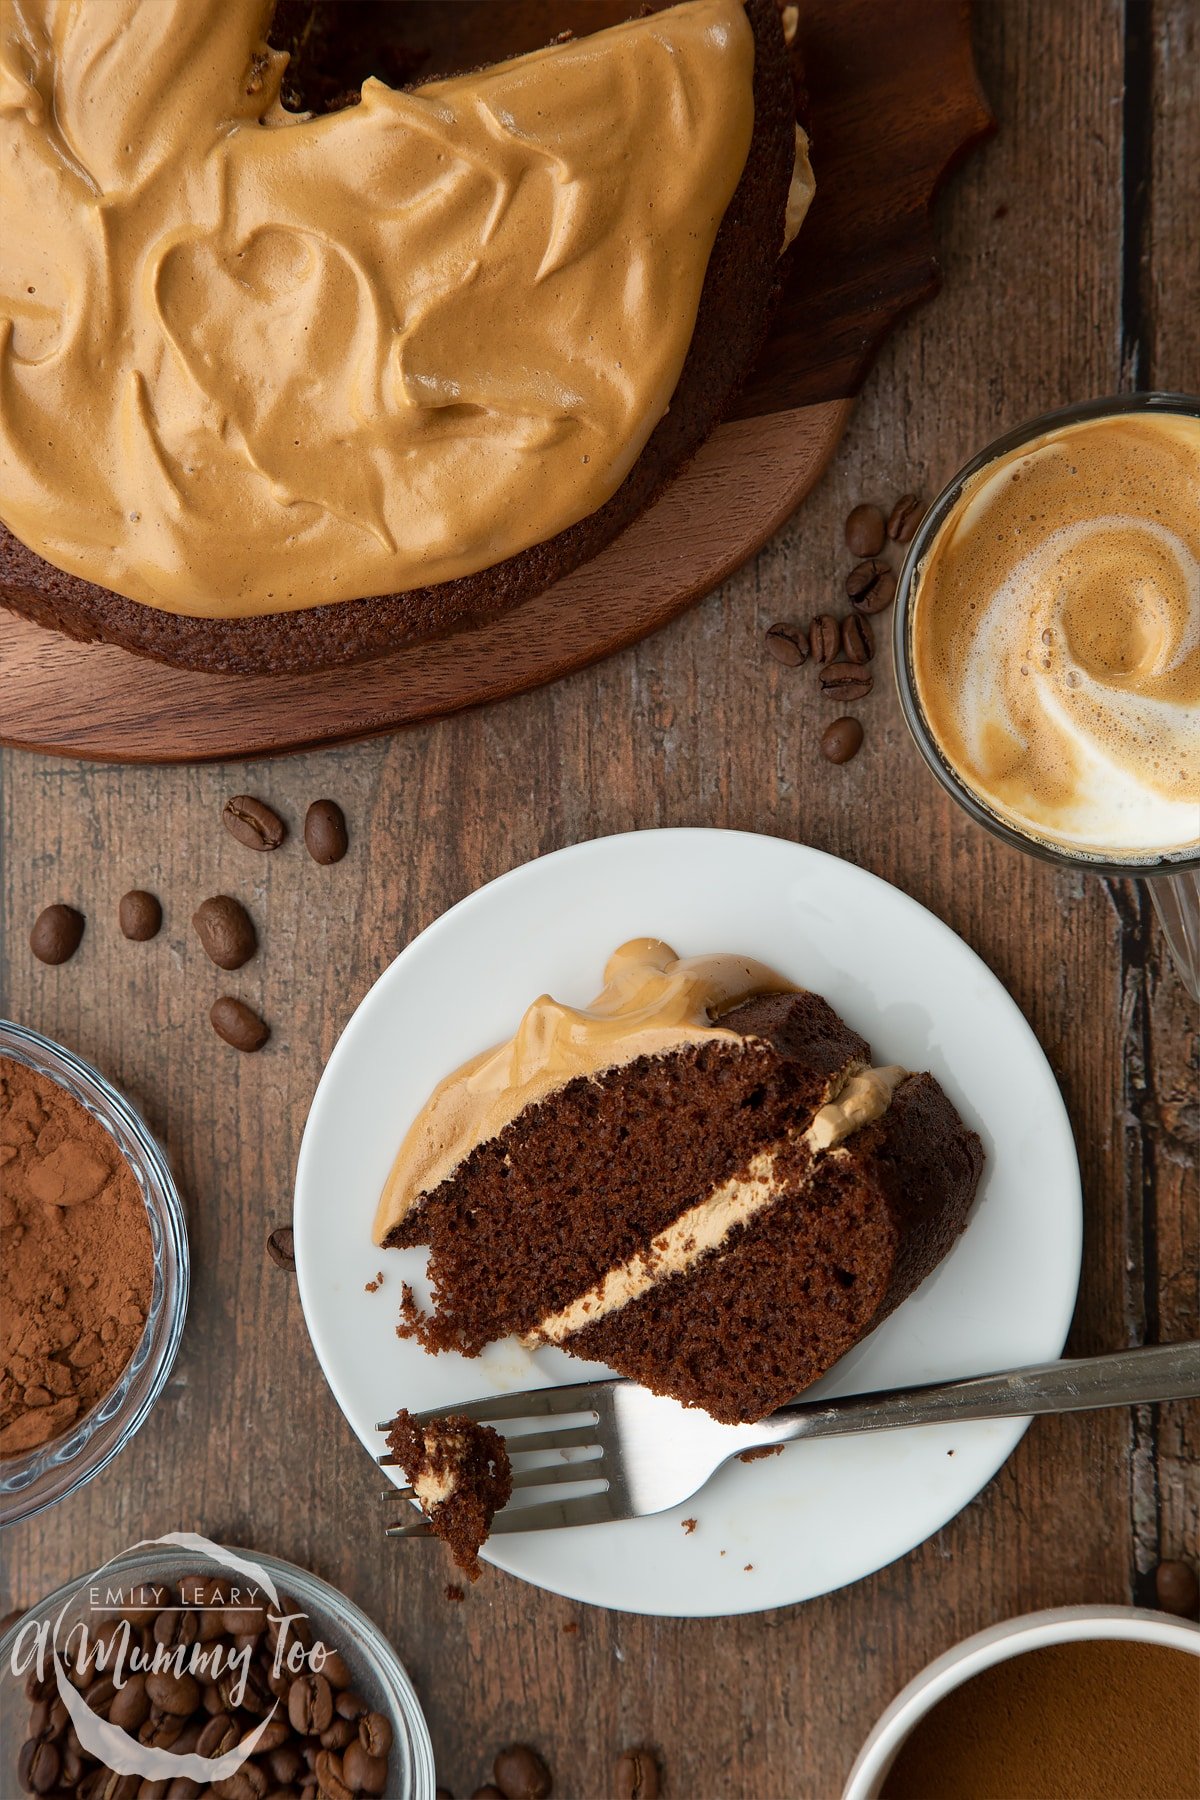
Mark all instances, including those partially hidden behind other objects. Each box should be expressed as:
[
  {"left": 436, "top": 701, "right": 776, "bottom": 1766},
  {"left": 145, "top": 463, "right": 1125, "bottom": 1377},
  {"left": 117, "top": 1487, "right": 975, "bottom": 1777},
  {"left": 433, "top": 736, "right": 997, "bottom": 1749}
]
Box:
[{"left": 554, "top": 1075, "right": 982, "bottom": 1422}]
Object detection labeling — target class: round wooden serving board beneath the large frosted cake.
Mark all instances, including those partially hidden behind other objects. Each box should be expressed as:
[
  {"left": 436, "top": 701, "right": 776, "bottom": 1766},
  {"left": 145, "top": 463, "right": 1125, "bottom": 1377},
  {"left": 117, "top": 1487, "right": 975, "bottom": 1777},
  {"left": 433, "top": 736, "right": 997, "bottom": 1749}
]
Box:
[{"left": 0, "top": 0, "right": 991, "bottom": 761}]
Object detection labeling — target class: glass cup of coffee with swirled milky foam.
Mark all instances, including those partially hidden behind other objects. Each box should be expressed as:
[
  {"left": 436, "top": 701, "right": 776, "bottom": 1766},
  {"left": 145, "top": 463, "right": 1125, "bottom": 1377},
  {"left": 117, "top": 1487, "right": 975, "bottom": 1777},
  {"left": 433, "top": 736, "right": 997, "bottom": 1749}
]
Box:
[{"left": 894, "top": 394, "right": 1200, "bottom": 999}]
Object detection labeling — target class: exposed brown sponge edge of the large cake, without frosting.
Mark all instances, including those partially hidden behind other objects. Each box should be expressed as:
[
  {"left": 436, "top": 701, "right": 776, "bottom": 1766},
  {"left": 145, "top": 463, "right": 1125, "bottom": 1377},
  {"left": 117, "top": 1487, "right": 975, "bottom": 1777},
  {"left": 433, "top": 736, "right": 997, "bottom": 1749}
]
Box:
[{"left": 0, "top": 0, "right": 795, "bottom": 673}]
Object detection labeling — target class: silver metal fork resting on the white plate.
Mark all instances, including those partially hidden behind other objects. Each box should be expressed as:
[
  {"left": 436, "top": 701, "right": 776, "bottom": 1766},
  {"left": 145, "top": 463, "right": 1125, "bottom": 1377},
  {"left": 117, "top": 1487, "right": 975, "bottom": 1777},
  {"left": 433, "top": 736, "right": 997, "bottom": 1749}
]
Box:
[{"left": 376, "top": 1343, "right": 1200, "bottom": 1537}]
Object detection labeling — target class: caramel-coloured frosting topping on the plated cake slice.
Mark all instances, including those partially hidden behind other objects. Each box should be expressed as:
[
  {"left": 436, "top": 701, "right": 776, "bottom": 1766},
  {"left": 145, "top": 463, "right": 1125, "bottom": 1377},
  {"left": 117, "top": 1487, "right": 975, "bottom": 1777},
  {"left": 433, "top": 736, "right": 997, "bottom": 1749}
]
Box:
[{"left": 374, "top": 938, "right": 795, "bottom": 1244}]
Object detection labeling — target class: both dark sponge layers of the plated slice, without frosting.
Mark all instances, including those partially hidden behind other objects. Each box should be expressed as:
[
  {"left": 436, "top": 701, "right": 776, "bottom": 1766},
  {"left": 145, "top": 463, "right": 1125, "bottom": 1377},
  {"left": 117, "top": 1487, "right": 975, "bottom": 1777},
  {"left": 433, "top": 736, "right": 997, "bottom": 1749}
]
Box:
[{"left": 389, "top": 994, "right": 982, "bottom": 1422}]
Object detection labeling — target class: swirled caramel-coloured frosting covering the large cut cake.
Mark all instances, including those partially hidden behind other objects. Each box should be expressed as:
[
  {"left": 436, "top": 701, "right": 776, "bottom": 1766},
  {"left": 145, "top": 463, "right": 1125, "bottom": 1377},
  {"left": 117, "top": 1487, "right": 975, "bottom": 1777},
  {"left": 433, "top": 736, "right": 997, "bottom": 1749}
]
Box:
[{"left": 0, "top": 0, "right": 766, "bottom": 619}]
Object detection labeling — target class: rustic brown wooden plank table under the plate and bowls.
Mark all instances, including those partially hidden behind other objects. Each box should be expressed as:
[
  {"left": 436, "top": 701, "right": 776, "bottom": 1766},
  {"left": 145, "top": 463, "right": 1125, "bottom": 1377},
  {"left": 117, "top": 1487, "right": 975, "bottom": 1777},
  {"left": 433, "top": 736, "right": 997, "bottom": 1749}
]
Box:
[{"left": 0, "top": 0, "right": 1200, "bottom": 1800}]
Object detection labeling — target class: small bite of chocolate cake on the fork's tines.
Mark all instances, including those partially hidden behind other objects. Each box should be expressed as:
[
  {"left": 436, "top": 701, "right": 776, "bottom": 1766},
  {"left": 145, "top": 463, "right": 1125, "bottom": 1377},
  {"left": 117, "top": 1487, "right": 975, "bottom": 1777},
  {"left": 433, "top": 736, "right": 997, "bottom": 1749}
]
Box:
[{"left": 387, "top": 1411, "right": 513, "bottom": 1580}]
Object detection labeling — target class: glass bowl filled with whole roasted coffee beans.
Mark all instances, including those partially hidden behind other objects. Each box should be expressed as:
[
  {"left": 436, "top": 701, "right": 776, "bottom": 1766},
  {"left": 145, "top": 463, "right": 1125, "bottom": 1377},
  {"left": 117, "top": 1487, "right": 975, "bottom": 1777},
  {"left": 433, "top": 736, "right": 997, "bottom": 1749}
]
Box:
[{"left": 0, "top": 1534, "right": 434, "bottom": 1800}]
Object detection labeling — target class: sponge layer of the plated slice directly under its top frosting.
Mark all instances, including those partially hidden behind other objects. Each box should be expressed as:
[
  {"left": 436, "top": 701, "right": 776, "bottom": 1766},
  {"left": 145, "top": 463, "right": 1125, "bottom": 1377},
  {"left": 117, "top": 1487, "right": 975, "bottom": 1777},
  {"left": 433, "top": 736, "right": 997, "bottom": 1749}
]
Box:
[{"left": 399, "top": 994, "right": 869, "bottom": 1355}]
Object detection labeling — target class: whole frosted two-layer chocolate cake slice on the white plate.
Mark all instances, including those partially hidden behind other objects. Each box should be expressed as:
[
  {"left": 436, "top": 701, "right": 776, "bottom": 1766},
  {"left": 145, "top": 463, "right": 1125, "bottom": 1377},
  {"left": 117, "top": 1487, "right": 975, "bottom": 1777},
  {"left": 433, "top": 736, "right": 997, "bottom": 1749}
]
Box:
[{"left": 376, "top": 940, "right": 982, "bottom": 1422}]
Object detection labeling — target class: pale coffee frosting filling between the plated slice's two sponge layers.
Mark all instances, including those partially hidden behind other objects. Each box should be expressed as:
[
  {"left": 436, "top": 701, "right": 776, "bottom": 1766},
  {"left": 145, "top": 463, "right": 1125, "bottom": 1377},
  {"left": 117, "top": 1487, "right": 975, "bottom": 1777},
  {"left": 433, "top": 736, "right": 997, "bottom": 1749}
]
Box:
[{"left": 522, "top": 1064, "right": 907, "bottom": 1348}]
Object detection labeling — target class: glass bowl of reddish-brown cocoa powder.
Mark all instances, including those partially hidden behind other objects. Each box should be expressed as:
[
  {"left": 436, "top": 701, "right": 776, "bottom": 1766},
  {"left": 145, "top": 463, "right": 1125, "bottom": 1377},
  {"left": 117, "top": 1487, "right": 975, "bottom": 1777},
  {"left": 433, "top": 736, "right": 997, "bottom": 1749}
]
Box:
[{"left": 0, "top": 1021, "right": 189, "bottom": 1525}]
